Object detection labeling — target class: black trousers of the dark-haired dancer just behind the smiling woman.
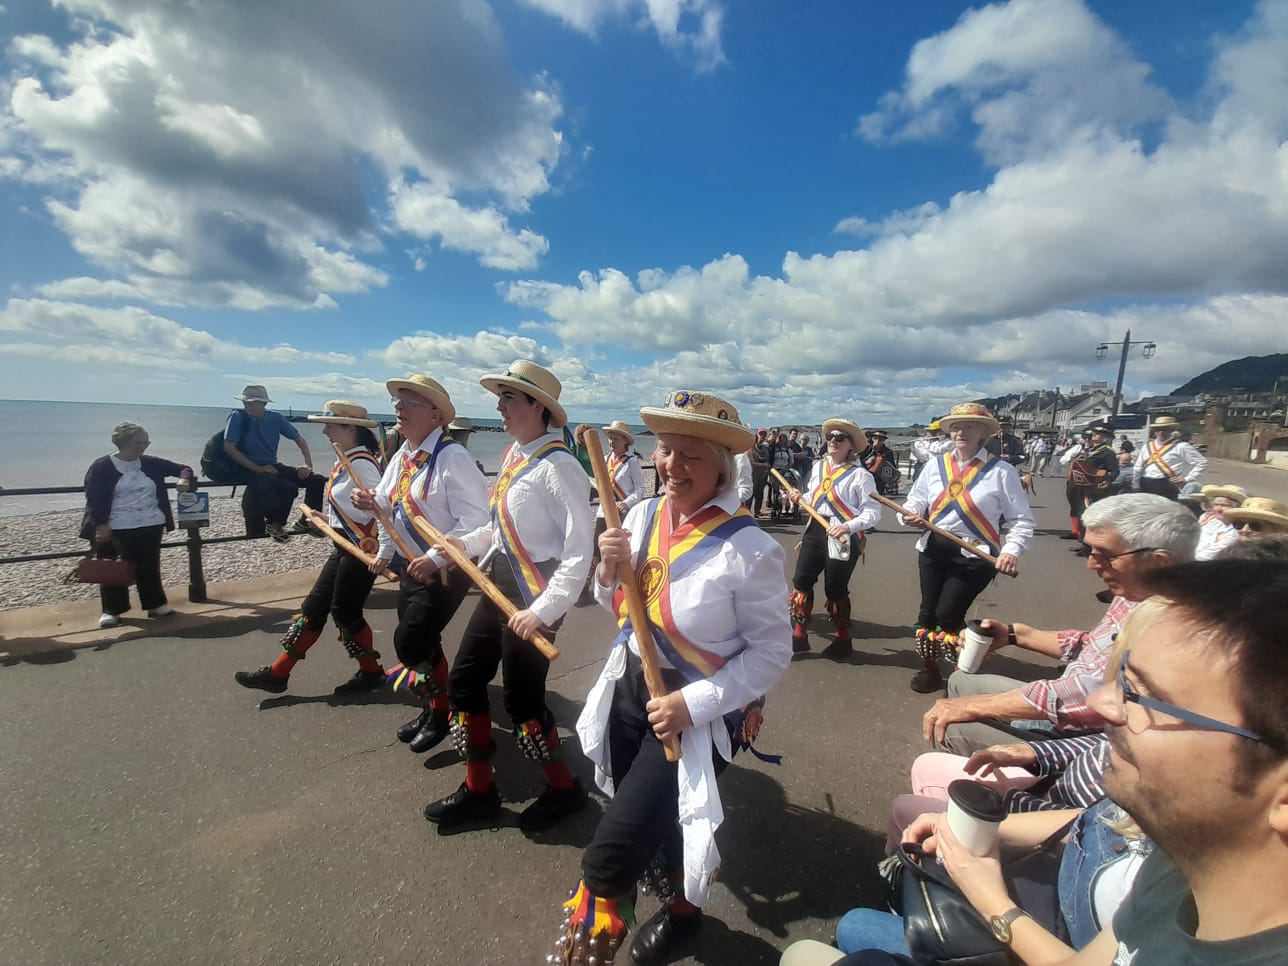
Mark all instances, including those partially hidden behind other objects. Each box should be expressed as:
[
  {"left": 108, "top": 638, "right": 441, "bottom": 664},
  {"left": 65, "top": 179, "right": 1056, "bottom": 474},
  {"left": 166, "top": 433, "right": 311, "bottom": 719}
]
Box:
[{"left": 447, "top": 555, "right": 563, "bottom": 729}]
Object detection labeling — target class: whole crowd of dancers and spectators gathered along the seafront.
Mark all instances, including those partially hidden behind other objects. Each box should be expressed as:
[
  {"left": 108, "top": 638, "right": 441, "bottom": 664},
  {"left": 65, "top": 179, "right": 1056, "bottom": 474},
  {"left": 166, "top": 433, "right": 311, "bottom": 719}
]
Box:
[{"left": 82, "top": 381, "right": 1288, "bottom": 966}]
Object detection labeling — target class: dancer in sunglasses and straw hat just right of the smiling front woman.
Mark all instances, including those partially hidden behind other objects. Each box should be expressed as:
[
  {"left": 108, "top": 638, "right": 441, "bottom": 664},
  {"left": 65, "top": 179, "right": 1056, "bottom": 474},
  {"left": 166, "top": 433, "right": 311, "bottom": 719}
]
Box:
[{"left": 774, "top": 419, "right": 881, "bottom": 659}]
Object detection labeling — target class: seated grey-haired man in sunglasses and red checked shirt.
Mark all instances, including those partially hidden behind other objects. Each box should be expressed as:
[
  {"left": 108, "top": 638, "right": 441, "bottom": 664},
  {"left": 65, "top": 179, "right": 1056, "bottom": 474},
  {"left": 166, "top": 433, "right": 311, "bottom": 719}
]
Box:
[{"left": 922, "top": 493, "right": 1199, "bottom": 756}]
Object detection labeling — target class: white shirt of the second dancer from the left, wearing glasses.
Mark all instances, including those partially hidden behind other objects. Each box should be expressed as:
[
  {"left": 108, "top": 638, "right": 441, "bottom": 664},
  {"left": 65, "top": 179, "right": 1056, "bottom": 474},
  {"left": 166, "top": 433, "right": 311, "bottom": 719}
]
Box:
[{"left": 376, "top": 428, "right": 494, "bottom": 567}]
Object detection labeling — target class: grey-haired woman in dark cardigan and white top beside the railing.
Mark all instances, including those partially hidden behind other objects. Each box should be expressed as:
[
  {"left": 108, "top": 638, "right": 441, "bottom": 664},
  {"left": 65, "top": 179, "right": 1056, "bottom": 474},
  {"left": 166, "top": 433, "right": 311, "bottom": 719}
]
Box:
[{"left": 80, "top": 422, "right": 193, "bottom": 627}]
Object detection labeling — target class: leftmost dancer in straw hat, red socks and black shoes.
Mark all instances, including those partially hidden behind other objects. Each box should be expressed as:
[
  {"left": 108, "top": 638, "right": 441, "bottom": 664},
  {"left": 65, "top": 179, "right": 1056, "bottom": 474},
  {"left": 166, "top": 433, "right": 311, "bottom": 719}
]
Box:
[{"left": 233, "top": 399, "right": 392, "bottom": 694}]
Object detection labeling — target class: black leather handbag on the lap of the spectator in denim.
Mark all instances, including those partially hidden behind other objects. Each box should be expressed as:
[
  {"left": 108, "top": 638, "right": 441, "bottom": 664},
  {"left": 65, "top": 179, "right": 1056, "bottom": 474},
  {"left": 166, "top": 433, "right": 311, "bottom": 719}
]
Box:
[{"left": 891, "top": 818, "right": 1077, "bottom": 966}]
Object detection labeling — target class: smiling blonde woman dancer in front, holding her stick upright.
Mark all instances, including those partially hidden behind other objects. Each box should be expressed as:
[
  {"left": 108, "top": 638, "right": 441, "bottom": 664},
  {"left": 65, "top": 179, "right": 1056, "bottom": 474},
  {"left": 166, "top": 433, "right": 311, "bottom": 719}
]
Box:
[{"left": 553, "top": 390, "right": 791, "bottom": 965}]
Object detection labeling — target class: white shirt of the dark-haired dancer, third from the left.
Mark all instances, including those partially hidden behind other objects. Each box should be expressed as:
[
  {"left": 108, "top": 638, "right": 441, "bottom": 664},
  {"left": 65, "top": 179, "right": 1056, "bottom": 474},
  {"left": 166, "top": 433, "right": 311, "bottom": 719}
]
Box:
[{"left": 461, "top": 433, "right": 595, "bottom": 627}]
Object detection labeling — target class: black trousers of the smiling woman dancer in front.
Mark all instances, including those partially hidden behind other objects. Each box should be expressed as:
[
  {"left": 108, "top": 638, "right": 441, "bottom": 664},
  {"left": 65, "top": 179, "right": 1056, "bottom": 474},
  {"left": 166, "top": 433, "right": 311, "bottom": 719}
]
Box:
[{"left": 581, "top": 654, "right": 728, "bottom": 898}]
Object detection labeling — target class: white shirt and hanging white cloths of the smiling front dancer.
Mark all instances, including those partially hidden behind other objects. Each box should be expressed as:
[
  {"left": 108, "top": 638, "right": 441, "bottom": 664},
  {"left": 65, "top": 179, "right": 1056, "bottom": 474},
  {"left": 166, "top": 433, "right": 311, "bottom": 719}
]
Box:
[{"left": 577, "top": 492, "right": 792, "bottom": 905}]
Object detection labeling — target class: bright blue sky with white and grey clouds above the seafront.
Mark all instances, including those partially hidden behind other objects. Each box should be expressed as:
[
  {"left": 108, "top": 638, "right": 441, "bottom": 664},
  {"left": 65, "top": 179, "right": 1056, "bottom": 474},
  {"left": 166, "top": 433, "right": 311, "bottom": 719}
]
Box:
[{"left": 0, "top": 0, "right": 1288, "bottom": 425}]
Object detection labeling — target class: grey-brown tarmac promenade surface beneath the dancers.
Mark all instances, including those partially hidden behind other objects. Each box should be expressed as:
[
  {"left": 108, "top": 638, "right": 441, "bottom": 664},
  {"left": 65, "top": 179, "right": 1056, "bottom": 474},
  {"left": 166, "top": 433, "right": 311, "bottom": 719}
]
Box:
[{"left": 0, "top": 461, "right": 1288, "bottom": 966}]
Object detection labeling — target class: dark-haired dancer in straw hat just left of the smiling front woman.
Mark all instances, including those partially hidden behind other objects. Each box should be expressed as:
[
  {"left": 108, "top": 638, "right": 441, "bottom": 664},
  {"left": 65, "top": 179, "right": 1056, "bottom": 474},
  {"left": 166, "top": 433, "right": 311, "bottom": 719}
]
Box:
[{"left": 424, "top": 359, "right": 595, "bottom": 835}]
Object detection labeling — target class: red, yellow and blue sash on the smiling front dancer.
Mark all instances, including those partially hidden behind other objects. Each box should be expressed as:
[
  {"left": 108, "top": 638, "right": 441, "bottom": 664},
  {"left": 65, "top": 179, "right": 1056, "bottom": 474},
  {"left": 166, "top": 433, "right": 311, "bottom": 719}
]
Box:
[{"left": 613, "top": 497, "right": 756, "bottom": 681}]
